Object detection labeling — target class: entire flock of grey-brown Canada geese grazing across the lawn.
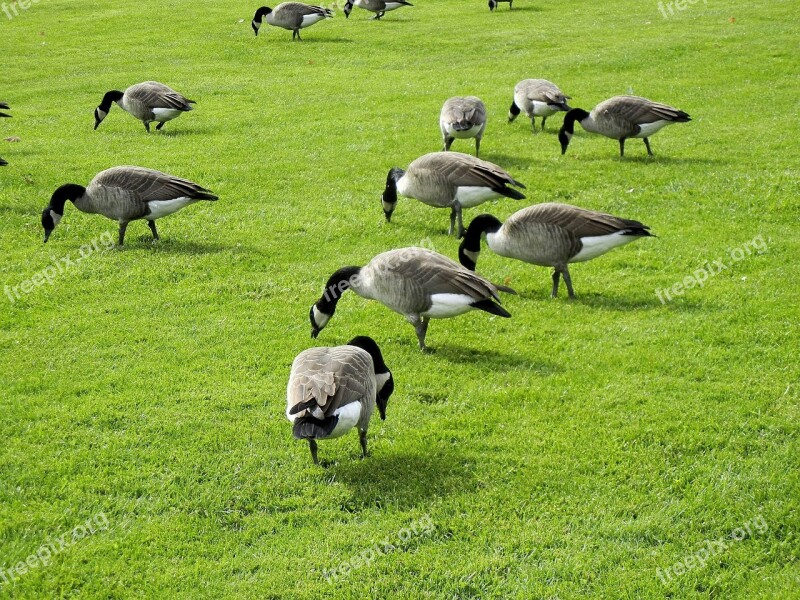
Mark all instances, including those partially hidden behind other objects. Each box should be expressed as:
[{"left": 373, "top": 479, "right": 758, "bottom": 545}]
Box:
[{"left": 0, "top": 0, "right": 691, "bottom": 464}]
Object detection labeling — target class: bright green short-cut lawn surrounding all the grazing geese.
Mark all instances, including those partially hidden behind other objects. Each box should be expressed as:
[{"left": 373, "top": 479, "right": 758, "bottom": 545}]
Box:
[{"left": 0, "top": 0, "right": 800, "bottom": 599}]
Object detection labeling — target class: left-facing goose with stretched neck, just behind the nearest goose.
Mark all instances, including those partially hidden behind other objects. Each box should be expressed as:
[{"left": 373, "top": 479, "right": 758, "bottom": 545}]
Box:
[{"left": 310, "top": 248, "right": 514, "bottom": 351}]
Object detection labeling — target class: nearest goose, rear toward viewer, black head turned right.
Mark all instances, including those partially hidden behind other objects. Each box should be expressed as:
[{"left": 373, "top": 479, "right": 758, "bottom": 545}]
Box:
[{"left": 286, "top": 336, "right": 394, "bottom": 465}]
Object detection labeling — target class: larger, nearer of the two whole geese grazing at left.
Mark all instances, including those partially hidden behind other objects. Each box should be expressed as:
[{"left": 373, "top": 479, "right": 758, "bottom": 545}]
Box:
[{"left": 42, "top": 167, "right": 217, "bottom": 246}]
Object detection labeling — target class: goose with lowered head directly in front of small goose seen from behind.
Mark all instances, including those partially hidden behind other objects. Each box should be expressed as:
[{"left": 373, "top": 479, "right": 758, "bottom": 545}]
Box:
[{"left": 381, "top": 152, "right": 525, "bottom": 237}]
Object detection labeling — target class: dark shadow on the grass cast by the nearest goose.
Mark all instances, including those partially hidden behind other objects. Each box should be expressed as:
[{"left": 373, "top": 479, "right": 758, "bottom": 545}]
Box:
[{"left": 325, "top": 450, "right": 474, "bottom": 512}]
